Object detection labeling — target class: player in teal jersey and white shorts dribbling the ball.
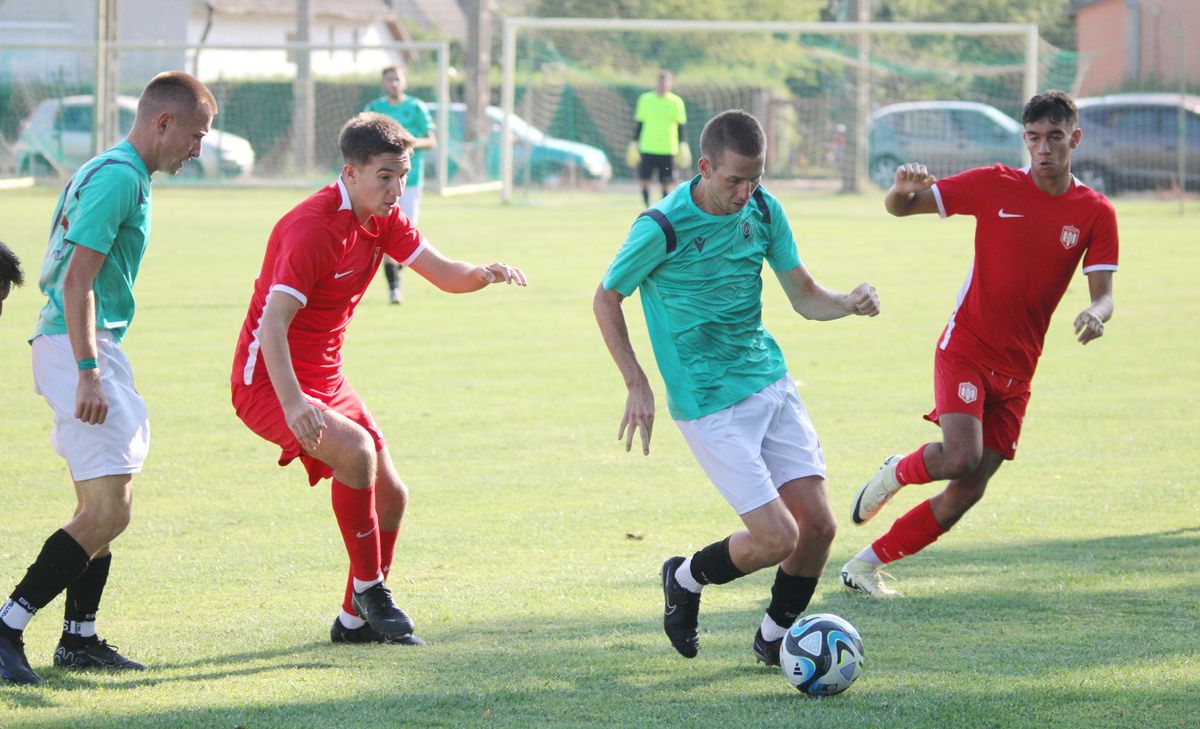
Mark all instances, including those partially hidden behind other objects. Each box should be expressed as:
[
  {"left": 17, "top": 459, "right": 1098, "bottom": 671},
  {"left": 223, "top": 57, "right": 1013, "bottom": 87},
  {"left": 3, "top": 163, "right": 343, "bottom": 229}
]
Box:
[{"left": 593, "top": 110, "right": 880, "bottom": 664}]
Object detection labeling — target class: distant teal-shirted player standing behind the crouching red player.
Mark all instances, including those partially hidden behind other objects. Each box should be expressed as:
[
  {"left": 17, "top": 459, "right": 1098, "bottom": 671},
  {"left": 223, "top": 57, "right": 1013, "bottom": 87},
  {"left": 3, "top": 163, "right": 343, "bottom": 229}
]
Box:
[{"left": 362, "top": 66, "right": 438, "bottom": 303}]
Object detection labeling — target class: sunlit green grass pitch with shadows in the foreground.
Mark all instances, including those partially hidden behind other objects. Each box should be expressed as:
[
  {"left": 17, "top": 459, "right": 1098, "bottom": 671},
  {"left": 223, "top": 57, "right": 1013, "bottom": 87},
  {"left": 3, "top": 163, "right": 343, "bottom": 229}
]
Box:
[{"left": 0, "top": 187, "right": 1200, "bottom": 729}]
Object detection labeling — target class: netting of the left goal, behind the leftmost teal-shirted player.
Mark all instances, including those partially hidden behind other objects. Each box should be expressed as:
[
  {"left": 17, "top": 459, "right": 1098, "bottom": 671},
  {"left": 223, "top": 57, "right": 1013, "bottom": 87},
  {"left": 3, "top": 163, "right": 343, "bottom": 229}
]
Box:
[{"left": 0, "top": 38, "right": 468, "bottom": 191}]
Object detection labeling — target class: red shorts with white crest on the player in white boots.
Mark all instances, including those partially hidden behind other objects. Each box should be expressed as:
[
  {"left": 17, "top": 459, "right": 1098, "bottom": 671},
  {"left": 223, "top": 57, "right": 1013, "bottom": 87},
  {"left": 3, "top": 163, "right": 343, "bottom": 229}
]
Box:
[{"left": 925, "top": 349, "right": 1030, "bottom": 460}]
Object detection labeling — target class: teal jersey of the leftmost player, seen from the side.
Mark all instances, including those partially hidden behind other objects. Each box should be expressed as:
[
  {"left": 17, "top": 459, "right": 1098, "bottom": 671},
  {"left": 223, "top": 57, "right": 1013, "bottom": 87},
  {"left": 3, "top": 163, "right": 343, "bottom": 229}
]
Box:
[{"left": 34, "top": 140, "right": 150, "bottom": 342}]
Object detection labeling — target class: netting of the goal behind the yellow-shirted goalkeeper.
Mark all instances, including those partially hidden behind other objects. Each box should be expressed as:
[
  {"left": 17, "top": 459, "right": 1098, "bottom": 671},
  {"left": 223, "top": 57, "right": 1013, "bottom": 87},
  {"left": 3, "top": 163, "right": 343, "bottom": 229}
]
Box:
[{"left": 503, "top": 18, "right": 1075, "bottom": 199}]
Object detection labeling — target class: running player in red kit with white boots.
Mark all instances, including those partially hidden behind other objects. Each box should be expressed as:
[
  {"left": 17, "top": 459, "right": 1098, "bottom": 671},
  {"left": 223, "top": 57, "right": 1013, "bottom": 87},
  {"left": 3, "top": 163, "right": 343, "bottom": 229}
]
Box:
[{"left": 841, "top": 91, "right": 1117, "bottom": 596}]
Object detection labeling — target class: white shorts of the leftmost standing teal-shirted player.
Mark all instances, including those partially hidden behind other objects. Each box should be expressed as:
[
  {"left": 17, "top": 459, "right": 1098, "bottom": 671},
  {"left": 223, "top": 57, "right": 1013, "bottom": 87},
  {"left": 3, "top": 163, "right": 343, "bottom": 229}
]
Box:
[{"left": 34, "top": 332, "right": 150, "bottom": 481}]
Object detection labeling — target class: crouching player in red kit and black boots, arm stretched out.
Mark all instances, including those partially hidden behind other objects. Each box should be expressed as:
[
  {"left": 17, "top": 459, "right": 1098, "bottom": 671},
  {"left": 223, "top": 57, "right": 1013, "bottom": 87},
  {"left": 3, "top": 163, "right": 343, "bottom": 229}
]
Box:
[{"left": 232, "top": 113, "right": 526, "bottom": 645}]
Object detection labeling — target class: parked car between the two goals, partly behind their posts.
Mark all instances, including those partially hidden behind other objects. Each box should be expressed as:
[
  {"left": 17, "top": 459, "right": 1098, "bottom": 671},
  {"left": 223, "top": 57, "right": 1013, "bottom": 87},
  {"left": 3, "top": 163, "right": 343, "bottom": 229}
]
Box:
[{"left": 425, "top": 103, "right": 612, "bottom": 185}]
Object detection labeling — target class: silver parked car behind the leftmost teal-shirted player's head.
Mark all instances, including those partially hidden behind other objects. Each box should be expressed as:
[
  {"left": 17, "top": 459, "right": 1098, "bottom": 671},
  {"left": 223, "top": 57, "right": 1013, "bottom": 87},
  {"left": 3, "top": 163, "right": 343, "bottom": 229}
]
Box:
[{"left": 12, "top": 96, "right": 254, "bottom": 177}]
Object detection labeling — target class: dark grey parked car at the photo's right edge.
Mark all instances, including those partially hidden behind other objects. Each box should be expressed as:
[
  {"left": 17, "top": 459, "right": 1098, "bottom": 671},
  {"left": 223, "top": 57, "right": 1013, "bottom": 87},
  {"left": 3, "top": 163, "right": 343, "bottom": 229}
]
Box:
[{"left": 1070, "top": 94, "right": 1200, "bottom": 195}]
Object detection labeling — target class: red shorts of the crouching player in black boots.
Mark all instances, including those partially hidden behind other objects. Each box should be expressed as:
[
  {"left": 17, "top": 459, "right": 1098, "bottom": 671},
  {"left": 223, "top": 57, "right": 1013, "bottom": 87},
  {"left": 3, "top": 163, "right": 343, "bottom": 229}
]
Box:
[{"left": 233, "top": 378, "right": 384, "bottom": 486}]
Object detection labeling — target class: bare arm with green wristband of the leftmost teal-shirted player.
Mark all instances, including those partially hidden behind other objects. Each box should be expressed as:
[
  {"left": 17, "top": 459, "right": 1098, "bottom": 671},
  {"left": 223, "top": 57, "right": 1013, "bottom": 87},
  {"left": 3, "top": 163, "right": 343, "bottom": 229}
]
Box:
[{"left": 62, "top": 245, "right": 108, "bottom": 426}]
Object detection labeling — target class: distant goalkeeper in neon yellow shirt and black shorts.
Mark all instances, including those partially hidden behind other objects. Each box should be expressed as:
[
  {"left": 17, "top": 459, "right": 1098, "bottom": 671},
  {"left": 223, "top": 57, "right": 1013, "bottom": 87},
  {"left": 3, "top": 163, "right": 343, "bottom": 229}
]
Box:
[{"left": 625, "top": 71, "right": 691, "bottom": 207}]
